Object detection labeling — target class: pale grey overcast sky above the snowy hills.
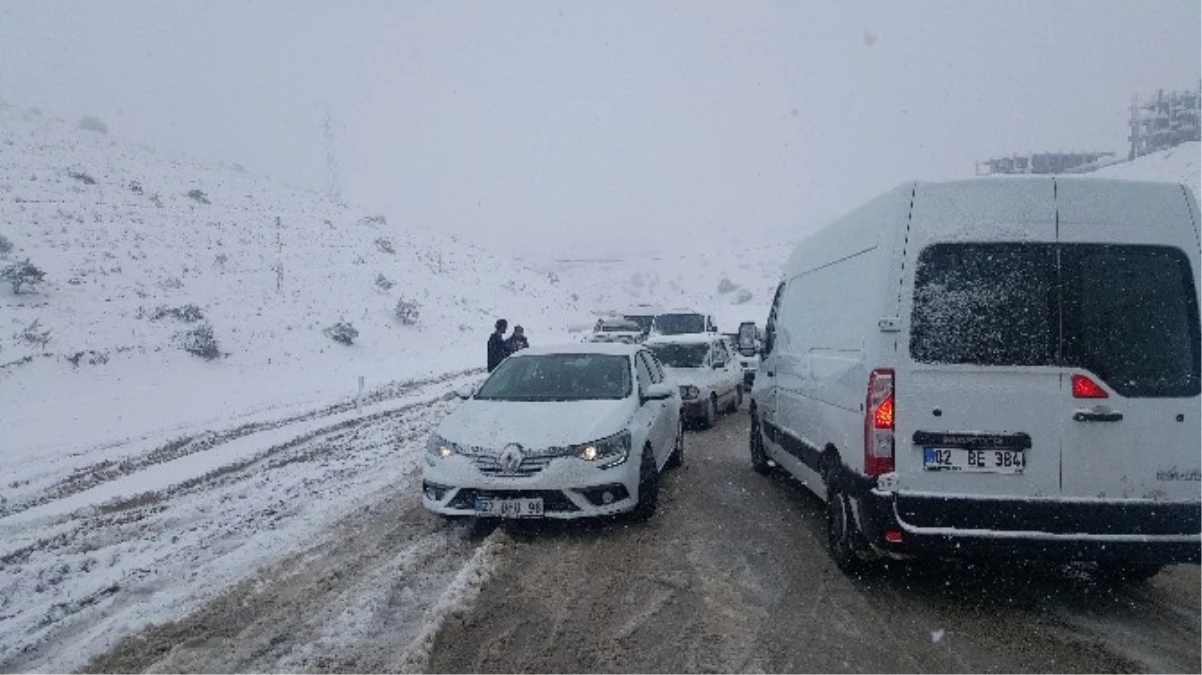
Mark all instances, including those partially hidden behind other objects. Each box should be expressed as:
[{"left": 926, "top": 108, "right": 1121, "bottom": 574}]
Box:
[{"left": 0, "top": 0, "right": 1202, "bottom": 257}]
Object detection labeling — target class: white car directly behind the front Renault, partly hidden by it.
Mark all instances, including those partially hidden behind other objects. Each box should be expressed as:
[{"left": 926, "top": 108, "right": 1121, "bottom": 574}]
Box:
[{"left": 645, "top": 333, "right": 743, "bottom": 429}]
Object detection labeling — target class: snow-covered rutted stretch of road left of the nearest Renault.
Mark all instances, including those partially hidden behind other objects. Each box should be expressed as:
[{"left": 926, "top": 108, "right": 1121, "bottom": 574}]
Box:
[{"left": 0, "top": 371, "right": 492, "bottom": 673}]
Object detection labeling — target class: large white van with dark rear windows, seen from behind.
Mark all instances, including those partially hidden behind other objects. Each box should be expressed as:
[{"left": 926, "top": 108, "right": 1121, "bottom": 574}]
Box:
[{"left": 750, "top": 177, "right": 1202, "bottom": 579}]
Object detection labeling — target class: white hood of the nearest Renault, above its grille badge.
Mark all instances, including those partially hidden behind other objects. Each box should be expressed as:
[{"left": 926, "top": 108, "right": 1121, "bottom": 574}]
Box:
[{"left": 438, "top": 399, "right": 633, "bottom": 448}]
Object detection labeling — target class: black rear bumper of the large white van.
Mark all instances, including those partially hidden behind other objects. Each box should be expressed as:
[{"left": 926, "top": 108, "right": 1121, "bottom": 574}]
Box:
[{"left": 861, "top": 489, "right": 1202, "bottom": 563}]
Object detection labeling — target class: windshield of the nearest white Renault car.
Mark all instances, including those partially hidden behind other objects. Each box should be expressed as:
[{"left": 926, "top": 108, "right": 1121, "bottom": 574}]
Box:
[{"left": 476, "top": 354, "right": 631, "bottom": 401}]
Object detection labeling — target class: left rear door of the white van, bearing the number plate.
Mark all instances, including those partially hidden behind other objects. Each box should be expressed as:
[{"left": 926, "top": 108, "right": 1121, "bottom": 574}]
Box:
[{"left": 894, "top": 179, "right": 1063, "bottom": 497}]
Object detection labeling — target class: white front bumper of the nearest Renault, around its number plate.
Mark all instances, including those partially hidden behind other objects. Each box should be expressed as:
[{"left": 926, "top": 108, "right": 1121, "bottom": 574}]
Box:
[{"left": 422, "top": 453, "right": 638, "bottom": 520}]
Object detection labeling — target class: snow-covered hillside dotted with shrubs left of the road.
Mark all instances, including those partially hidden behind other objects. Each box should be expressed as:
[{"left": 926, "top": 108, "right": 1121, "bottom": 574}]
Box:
[{"left": 0, "top": 107, "right": 573, "bottom": 451}]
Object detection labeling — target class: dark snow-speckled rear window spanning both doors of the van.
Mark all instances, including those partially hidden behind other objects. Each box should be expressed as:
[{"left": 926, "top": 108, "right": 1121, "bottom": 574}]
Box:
[{"left": 910, "top": 244, "right": 1202, "bottom": 396}]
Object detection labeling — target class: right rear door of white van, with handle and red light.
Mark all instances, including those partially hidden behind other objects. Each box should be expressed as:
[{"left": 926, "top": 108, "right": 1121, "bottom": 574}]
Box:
[{"left": 1057, "top": 179, "right": 1202, "bottom": 501}]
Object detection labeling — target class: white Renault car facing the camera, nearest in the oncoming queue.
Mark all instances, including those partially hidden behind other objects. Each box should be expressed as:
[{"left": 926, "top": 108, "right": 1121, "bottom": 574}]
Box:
[{"left": 422, "top": 344, "right": 684, "bottom": 519}]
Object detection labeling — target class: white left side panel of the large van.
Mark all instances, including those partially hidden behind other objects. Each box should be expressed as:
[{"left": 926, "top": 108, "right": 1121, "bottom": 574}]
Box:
[{"left": 772, "top": 186, "right": 911, "bottom": 482}]
